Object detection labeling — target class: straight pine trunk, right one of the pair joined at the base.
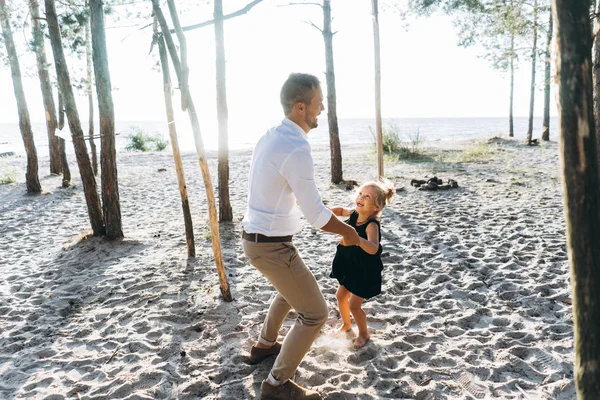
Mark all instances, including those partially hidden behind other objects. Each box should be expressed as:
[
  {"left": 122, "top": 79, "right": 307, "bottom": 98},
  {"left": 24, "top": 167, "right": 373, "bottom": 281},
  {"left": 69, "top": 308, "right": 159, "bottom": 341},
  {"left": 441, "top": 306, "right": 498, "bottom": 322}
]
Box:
[{"left": 90, "top": 0, "right": 123, "bottom": 240}]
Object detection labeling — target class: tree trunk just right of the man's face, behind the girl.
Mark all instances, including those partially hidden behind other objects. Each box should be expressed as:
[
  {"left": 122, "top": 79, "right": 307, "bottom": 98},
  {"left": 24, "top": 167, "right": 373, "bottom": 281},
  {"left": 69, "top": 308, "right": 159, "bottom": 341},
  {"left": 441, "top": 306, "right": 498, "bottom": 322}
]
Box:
[{"left": 323, "top": 0, "right": 344, "bottom": 183}]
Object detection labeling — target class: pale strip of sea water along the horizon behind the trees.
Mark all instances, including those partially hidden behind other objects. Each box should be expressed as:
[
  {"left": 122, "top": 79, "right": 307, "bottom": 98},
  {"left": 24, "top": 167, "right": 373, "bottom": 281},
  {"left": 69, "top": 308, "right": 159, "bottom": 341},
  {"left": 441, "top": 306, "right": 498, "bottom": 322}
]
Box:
[{"left": 0, "top": 115, "right": 558, "bottom": 157}]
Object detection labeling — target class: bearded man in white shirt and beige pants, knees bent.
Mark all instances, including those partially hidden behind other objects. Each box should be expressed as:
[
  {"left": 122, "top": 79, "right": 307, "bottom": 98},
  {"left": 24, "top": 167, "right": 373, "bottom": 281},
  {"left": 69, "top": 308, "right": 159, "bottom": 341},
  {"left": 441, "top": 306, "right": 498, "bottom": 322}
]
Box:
[{"left": 242, "top": 74, "right": 359, "bottom": 400}]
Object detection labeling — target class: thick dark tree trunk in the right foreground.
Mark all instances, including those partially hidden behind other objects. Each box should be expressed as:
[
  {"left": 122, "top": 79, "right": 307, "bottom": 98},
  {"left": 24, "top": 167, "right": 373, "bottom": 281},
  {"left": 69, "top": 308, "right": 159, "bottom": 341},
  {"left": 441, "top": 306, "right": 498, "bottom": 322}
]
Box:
[{"left": 553, "top": 0, "right": 600, "bottom": 400}]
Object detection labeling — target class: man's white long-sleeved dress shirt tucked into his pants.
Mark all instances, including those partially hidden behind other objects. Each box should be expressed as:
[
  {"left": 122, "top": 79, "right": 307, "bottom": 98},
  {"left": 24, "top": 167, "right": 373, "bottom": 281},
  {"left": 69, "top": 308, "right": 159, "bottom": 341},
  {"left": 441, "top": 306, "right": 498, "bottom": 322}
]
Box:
[{"left": 242, "top": 118, "right": 333, "bottom": 236}]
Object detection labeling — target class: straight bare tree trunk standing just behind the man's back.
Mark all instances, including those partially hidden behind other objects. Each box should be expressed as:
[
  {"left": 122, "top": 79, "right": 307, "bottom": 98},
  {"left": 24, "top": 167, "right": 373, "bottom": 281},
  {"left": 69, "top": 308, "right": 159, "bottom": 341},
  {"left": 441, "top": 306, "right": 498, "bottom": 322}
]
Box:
[{"left": 214, "top": 0, "right": 233, "bottom": 221}]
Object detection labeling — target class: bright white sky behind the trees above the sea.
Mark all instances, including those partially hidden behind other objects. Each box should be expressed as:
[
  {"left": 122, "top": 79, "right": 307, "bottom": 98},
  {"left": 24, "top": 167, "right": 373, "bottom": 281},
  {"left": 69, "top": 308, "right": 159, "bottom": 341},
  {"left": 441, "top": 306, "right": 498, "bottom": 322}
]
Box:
[{"left": 0, "top": 0, "right": 556, "bottom": 126}]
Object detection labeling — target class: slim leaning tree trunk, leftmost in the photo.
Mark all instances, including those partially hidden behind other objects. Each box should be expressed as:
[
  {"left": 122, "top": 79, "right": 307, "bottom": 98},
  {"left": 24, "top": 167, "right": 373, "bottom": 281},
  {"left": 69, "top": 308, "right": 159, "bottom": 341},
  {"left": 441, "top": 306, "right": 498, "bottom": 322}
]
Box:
[{"left": 0, "top": 0, "right": 42, "bottom": 193}]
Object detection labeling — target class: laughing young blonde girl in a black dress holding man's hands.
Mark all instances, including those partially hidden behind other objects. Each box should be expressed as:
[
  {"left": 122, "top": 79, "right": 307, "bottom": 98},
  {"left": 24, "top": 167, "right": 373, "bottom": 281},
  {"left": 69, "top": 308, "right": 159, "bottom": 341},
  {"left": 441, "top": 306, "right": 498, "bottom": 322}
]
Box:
[{"left": 330, "top": 181, "right": 395, "bottom": 349}]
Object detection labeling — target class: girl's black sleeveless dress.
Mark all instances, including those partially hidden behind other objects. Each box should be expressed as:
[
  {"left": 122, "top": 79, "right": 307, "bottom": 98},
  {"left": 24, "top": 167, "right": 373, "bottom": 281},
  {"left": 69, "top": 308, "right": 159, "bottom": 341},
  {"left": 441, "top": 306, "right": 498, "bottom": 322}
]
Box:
[{"left": 329, "top": 211, "right": 383, "bottom": 299}]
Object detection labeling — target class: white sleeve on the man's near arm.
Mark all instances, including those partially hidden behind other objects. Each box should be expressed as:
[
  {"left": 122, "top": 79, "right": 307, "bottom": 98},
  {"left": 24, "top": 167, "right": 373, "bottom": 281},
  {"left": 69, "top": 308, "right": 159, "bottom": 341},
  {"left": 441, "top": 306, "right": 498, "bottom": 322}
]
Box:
[{"left": 281, "top": 148, "right": 333, "bottom": 229}]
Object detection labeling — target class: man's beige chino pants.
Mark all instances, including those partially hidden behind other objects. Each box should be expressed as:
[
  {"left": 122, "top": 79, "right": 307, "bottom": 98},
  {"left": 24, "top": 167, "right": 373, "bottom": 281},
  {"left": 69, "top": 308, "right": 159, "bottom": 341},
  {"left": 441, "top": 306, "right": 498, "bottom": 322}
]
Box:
[{"left": 242, "top": 240, "right": 328, "bottom": 382}]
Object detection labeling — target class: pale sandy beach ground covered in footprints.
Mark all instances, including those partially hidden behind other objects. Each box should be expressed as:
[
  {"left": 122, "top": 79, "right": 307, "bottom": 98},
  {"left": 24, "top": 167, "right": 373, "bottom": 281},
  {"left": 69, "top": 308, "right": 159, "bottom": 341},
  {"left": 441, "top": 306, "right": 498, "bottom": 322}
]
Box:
[{"left": 0, "top": 139, "right": 576, "bottom": 400}]
